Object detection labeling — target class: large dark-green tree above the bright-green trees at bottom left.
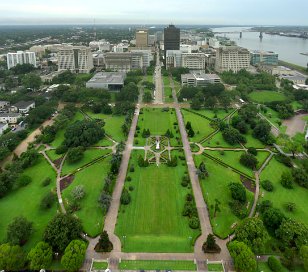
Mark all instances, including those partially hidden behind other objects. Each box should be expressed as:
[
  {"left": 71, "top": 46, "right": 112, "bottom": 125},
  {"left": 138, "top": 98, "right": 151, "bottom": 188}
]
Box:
[{"left": 43, "top": 213, "right": 82, "bottom": 252}]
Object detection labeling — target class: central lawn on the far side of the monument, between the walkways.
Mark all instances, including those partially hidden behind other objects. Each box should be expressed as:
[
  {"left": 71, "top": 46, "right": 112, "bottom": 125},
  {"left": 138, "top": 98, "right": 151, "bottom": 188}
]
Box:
[{"left": 135, "top": 108, "right": 182, "bottom": 146}]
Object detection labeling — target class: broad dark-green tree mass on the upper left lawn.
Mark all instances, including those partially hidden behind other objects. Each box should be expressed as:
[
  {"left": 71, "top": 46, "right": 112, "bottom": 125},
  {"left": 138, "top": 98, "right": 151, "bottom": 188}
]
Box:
[{"left": 64, "top": 120, "right": 105, "bottom": 147}]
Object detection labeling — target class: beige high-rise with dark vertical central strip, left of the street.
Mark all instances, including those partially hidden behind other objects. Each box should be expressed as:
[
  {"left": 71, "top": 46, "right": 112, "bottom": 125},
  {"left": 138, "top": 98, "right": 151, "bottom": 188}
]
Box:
[{"left": 58, "top": 46, "right": 94, "bottom": 73}]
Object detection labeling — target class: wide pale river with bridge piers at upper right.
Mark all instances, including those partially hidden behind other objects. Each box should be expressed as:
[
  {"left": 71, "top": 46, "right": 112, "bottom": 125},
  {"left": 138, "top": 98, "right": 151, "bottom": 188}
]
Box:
[{"left": 212, "top": 27, "right": 308, "bottom": 67}]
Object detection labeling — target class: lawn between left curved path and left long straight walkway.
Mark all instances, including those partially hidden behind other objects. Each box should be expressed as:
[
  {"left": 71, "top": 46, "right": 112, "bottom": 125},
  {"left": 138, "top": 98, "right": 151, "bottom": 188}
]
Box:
[{"left": 62, "top": 157, "right": 110, "bottom": 237}]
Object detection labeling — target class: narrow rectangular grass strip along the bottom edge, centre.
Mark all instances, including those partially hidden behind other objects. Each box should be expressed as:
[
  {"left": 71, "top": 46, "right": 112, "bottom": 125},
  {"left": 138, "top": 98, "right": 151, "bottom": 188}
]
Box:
[{"left": 119, "top": 261, "right": 197, "bottom": 271}]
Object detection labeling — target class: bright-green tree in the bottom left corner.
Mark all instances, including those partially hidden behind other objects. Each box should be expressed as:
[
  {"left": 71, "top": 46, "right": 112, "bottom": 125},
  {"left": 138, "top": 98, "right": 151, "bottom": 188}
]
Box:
[{"left": 0, "top": 244, "right": 26, "bottom": 271}]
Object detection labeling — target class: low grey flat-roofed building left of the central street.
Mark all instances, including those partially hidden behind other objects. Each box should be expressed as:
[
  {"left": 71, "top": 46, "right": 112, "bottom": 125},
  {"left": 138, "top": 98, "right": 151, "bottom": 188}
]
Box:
[{"left": 86, "top": 72, "right": 126, "bottom": 91}]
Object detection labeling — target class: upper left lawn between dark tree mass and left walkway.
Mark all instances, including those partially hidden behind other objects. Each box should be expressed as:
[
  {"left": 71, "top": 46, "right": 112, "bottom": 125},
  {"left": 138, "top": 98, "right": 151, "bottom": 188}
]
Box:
[{"left": 87, "top": 112, "right": 126, "bottom": 142}]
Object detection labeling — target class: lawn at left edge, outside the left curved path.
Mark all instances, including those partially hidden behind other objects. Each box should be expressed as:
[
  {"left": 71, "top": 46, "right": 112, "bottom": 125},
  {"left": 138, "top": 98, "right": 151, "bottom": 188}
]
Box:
[{"left": 0, "top": 156, "right": 57, "bottom": 250}]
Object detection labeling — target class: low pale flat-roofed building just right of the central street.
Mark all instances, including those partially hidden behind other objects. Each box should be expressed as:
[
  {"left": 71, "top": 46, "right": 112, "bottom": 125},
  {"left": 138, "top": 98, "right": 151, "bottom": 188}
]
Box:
[{"left": 181, "top": 73, "right": 221, "bottom": 87}]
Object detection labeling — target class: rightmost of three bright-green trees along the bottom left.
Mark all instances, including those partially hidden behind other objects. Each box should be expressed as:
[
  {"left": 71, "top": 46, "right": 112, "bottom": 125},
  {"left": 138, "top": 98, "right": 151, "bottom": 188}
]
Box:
[{"left": 61, "top": 240, "right": 87, "bottom": 271}]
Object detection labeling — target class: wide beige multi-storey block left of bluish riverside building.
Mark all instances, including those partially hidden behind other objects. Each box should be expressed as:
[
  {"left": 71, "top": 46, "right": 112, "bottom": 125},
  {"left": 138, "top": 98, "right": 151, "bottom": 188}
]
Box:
[{"left": 215, "top": 46, "right": 250, "bottom": 73}]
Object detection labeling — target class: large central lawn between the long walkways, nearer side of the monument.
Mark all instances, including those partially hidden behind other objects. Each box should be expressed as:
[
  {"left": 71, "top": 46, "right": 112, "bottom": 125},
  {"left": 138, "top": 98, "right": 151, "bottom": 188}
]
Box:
[{"left": 115, "top": 151, "right": 200, "bottom": 252}]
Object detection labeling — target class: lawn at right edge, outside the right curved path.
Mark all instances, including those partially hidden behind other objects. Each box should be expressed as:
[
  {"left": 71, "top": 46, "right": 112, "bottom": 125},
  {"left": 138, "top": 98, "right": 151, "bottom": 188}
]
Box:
[{"left": 260, "top": 158, "right": 308, "bottom": 226}]
